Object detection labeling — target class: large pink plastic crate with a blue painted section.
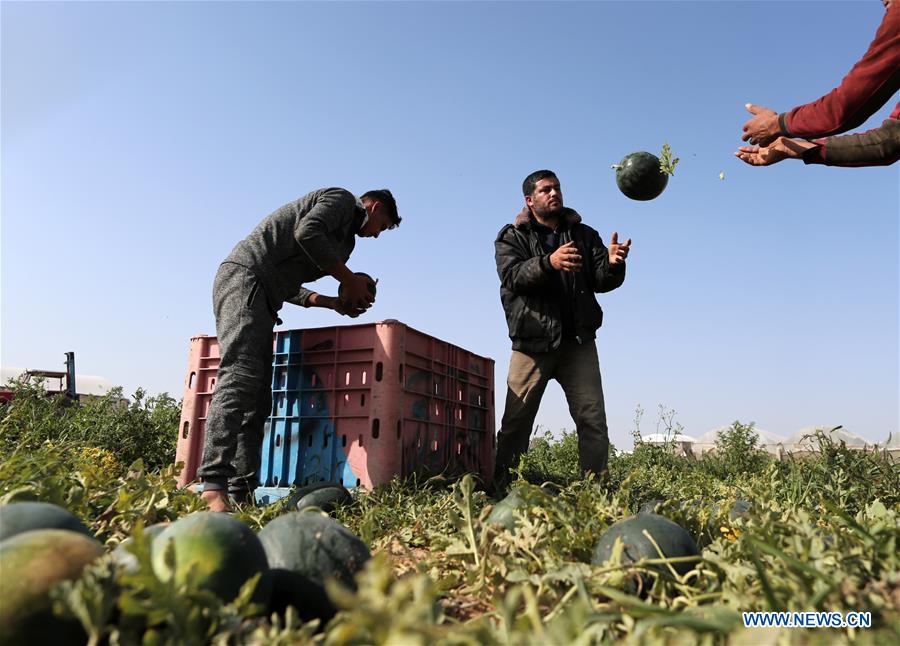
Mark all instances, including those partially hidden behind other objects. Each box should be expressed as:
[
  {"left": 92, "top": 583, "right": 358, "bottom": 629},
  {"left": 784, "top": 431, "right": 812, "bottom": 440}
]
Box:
[{"left": 176, "top": 321, "right": 495, "bottom": 488}]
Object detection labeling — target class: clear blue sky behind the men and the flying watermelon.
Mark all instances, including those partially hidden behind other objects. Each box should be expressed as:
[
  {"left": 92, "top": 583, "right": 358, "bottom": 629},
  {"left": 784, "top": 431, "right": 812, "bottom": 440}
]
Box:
[{"left": 0, "top": 0, "right": 900, "bottom": 447}]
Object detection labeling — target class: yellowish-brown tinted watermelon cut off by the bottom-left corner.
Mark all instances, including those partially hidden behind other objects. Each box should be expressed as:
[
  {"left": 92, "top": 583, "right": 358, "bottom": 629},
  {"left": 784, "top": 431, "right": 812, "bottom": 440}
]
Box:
[{"left": 0, "top": 528, "right": 103, "bottom": 646}]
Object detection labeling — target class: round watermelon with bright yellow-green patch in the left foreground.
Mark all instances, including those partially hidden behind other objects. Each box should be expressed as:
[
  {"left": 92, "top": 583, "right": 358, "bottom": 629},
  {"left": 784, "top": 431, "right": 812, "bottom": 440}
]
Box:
[{"left": 152, "top": 511, "right": 269, "bottom": 603}]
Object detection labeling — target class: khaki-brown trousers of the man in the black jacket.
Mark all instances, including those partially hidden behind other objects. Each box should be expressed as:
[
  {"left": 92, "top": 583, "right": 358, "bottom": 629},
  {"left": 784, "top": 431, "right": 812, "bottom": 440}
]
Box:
[{"left": 494, "top": 340, "right": 609, "bottom": 490}]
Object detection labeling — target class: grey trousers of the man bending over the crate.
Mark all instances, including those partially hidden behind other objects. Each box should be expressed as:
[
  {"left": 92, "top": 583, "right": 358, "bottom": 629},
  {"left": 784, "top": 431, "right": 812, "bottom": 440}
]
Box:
[{"left": 197, "top": 263, "right": 277, "bottom": 496}]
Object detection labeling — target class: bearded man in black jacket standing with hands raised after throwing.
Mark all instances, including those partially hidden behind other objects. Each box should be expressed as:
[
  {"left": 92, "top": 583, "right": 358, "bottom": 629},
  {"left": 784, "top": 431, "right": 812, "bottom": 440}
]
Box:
[{"left": 493, "top": 170, "right": 631, "bottom": 494}]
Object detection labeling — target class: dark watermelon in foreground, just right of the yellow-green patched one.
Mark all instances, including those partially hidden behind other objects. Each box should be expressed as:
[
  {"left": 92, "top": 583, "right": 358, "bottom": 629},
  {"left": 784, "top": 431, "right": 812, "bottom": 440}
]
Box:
[{"left": 259, "top": 511, "right": 371, "bottom": 621}]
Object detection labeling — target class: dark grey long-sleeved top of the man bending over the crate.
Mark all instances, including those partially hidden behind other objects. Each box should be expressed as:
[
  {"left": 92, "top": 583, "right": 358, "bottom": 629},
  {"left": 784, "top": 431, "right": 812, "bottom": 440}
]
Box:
[{"left": 223, "top": 188, "right": 366, "bottom": 312}]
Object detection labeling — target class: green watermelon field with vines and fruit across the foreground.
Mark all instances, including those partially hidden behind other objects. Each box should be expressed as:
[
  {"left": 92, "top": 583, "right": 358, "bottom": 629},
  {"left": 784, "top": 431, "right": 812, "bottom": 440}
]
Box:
[{"left": 0, "top": 383, "right": 900, "bottom": 645}]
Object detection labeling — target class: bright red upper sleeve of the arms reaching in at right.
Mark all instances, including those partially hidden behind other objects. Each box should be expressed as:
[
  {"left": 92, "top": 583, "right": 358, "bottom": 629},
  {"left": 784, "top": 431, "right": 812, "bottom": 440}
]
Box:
[{"left": 780, "top": 2, "right": 900, "bottom": 138}]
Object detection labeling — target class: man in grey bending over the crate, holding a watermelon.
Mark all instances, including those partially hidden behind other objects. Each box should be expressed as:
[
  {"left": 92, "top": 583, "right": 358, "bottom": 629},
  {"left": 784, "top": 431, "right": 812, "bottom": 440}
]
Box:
[{"left": 204, "top": 188, "right": 400, "bottom": 511}]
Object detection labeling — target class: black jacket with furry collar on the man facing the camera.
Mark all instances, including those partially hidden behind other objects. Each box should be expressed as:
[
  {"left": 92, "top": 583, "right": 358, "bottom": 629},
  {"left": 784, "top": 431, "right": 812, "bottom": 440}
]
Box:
[{"left": 494, "top": 207, "right": 625, "bottom": 352}]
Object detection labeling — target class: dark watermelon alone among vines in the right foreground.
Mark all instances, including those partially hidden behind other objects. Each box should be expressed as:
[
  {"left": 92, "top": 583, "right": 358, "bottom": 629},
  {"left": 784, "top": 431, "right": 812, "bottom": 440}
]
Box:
[{"left": 591, "top": 513, "right": 700, "bottom": 574}]
